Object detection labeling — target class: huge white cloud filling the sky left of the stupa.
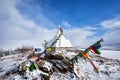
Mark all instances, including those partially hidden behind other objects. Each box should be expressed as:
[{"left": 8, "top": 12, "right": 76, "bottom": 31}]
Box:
[{"left": 0, "top": 0, "right": 56, "bottom": 48}]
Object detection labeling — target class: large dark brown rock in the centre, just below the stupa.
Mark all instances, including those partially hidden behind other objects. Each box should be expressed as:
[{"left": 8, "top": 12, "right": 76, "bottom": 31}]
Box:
[{"left": 42, "top": 54, "right": 73, "bottom": 73}]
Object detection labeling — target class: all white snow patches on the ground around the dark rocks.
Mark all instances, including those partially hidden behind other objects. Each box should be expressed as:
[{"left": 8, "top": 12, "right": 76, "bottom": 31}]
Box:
[{"left": 0, "top": 50, "right": 120, "bottom": 80}]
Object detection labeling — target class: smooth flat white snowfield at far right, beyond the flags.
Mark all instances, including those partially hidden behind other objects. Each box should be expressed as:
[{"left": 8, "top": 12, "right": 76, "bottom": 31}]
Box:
[{"left": 101, "top": 50, "right": 120, "bottom": 60}]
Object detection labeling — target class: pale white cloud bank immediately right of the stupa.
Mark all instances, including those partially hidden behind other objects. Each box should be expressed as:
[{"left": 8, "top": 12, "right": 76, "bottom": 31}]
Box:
[{"left": 64, "top": 28, "right": 98, "bottom": 48}]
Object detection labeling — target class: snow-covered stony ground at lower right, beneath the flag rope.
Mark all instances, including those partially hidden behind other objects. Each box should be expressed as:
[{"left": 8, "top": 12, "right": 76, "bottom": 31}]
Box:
[{"left": 74, "top": 58, "right": 120, "bottom": 80}]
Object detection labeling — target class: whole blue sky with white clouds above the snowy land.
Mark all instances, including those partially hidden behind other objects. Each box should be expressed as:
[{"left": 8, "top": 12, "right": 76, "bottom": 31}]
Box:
[{"left": 0, "top": 0, "right": 120, "bottom": 49}]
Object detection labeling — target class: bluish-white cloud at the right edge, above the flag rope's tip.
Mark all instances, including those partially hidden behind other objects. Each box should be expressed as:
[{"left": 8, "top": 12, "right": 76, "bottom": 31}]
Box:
[{"left": 101, "top": 17, "right": 120, "bottom": 44}]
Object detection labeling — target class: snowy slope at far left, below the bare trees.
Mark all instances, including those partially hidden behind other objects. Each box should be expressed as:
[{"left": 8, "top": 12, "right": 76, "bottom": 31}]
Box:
[{"left": 0, "top": 53, "right": 27, "bottom": 76}]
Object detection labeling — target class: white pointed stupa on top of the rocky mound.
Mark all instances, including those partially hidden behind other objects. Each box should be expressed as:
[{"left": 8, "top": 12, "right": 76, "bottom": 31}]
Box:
[{"left": 47, "top": 26, "right": 72, "bottom": 48}]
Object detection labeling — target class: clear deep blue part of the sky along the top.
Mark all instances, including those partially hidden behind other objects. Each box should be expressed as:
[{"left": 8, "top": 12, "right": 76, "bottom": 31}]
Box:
[{"left": 18, "top": 0, "right": 120, "bottom": 26}]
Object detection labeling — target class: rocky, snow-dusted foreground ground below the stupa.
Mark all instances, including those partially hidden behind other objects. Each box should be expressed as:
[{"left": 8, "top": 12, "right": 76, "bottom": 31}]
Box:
[{"left": 0, "top": 50, "right": 120, "bottom": 80}]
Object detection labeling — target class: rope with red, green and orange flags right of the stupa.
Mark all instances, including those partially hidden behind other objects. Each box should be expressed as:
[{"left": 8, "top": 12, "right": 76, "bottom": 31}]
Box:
[{"left": 71, "top": 39, "right": 103, "bottom": 73}]
